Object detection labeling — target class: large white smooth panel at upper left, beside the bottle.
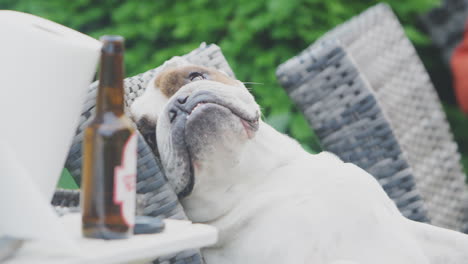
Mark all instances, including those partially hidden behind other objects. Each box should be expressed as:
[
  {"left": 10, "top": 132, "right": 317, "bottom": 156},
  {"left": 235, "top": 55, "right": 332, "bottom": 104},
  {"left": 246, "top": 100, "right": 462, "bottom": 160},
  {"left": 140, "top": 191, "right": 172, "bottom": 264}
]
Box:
[{"left": 0, "top": 11, "right": 101, "bottom": 200}]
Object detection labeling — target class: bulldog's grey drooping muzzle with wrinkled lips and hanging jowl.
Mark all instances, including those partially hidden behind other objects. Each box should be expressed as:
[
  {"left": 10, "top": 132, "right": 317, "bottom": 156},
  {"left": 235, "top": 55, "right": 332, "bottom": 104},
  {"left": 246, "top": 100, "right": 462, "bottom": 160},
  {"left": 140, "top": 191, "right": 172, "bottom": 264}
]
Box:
[{"left": 163, "top": 91, "right": 260, "bottom": 197}]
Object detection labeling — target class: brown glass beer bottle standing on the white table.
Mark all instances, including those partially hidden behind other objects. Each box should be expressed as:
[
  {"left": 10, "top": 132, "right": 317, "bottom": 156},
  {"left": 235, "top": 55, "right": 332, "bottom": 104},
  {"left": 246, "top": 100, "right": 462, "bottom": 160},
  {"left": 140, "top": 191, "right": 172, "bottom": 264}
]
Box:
[{"left": 81, "top": 36, "right": 137, "bottom": 239}]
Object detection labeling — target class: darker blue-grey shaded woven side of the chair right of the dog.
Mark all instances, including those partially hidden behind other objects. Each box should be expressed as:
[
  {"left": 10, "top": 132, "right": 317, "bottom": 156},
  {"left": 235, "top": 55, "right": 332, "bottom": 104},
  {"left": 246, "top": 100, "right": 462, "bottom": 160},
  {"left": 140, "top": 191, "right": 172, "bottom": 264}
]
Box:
[{"left": 278, "top": 43, "right": 428, "bottom": 221}]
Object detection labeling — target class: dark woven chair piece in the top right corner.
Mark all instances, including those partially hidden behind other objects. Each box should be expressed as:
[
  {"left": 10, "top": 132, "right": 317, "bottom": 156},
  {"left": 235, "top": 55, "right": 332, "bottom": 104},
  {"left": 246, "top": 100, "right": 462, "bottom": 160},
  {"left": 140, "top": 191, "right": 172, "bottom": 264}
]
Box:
[{"left": 420, "top": 0, "right": 468, "bottom": 64}]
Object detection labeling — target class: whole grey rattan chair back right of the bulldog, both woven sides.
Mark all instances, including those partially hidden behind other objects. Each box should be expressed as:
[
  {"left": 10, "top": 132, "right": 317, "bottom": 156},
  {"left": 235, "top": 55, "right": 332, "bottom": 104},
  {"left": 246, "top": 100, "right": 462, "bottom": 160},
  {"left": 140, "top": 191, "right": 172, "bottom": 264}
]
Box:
[{"left": 277, "top": 4, "right": 468, "bottom": 232}]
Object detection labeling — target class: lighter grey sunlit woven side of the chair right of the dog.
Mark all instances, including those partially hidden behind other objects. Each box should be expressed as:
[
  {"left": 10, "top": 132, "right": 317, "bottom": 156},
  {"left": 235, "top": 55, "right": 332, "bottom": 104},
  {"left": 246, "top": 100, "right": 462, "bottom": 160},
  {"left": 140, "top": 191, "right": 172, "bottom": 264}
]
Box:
[{"left": 278, "top": 4, "right": 468, "bottom": 232}]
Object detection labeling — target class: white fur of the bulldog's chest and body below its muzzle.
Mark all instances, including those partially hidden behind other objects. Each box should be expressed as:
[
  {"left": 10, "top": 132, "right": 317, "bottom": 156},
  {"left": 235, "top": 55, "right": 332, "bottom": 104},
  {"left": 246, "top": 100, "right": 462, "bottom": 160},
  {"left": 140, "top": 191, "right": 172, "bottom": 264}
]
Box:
[{"left": 132, "top": 59, "right": 468, "bottom": 264}]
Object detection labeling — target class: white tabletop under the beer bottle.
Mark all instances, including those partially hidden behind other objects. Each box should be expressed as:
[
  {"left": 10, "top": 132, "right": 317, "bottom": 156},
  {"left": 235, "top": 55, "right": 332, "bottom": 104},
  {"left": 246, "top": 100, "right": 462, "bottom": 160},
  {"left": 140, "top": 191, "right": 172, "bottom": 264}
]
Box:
[{"left": 6, "top": 214, "right": 218, "bottom": 264}]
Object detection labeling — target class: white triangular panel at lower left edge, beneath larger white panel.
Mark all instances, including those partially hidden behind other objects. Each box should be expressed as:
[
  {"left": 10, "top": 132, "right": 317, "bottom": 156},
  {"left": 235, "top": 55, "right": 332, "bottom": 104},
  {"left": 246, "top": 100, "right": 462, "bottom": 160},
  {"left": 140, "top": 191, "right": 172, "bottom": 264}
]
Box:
[{"left": 0, "top": 139, "right": 75, "bottom": 246}]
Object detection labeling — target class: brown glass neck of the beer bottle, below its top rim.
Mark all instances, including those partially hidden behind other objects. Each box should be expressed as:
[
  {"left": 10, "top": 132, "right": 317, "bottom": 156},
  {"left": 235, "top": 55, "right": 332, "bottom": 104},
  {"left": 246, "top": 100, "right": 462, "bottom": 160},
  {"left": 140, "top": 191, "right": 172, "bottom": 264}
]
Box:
[{"left": 96, "top": 52, "right": 124, "bottom": 116}]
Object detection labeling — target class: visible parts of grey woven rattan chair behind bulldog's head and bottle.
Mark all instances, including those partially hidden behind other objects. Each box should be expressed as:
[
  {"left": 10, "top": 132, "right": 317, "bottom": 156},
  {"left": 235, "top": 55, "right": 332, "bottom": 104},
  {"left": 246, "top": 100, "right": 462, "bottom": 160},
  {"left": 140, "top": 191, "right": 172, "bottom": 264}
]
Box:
[{"left": 52, "top": 44, "right": 234, "bottom": 264}]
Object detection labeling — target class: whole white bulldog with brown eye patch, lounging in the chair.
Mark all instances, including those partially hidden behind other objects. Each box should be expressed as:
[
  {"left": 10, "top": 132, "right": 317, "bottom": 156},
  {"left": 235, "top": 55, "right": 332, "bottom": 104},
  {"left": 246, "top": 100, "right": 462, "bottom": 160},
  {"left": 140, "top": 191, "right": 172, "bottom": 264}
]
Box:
[{"left": 131, "top": 57, "right": 468, "bottom": 264}]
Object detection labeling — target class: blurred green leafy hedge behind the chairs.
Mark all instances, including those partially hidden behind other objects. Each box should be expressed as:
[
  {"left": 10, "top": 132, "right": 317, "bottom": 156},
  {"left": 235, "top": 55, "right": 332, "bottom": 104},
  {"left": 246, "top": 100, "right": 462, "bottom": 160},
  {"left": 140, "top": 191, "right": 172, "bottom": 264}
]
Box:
[{"left": 0, "top": 0, "right": 468, "bottom": 185}]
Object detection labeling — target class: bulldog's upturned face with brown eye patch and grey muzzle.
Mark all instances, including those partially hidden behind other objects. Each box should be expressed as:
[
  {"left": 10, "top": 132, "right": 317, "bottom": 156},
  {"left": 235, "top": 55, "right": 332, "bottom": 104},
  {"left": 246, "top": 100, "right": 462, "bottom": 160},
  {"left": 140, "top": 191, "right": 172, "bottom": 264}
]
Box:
[{"left": 131, "top": 57, "right": 260, "bottom": 196}]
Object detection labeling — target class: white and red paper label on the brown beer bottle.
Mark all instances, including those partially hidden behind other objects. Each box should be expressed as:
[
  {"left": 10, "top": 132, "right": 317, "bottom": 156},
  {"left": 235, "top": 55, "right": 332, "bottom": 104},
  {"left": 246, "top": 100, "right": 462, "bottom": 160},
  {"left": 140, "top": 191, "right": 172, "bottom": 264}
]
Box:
[{"left": 114, "top": 133, "right": 137, "bottom": 226}]
